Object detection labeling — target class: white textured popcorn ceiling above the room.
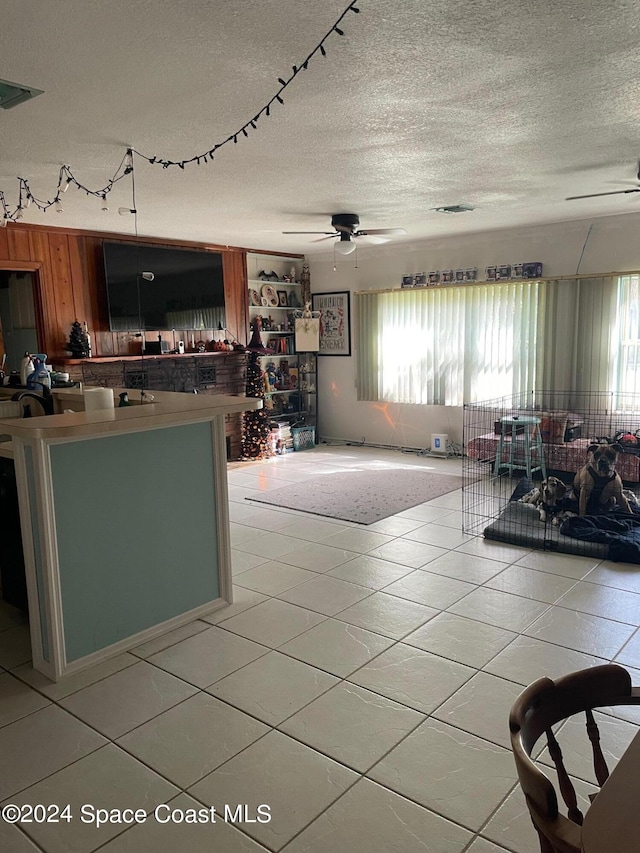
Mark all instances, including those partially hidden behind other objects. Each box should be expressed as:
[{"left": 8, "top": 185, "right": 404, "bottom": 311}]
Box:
[{"left": 0, "top": 0, "right": 640, "bottom": 253}]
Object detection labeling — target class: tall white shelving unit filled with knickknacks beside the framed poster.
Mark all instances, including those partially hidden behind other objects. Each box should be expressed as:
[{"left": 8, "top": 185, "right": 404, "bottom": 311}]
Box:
[{"left": 247, "top": 254, "right": 317, "bottom": 443}]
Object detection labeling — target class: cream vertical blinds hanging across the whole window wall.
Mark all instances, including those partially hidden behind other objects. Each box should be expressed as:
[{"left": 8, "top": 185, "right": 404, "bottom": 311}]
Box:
[{"left": 355, "top": 276, "right": 620, "bottom": 406}]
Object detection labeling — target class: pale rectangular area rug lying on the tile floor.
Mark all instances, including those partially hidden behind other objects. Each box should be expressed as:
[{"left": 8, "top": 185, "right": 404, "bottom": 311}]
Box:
[{"left": 247, "top": 468, "right": 462, "bottom": 524}]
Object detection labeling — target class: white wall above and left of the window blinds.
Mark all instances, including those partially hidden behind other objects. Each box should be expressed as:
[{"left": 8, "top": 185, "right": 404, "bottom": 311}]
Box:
[{"left": 309, "top": 211, "right": 640, "bottom": 448}]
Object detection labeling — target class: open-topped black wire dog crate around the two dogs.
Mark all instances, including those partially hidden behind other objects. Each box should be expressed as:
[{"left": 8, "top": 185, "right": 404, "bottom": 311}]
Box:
[{"left": 462, "top": 391, "right": 640, "bottom": 558}]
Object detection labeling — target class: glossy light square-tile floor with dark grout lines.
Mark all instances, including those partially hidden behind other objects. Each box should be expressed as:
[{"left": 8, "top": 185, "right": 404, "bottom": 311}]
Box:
[{"left": 0, "top": 447, "right": 640, "bottom": 853}]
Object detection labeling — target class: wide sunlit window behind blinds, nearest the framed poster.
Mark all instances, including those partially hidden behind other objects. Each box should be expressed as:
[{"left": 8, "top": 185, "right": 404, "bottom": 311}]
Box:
[{"left": 356, "top": 281, "right": 548, "bottom": 406}]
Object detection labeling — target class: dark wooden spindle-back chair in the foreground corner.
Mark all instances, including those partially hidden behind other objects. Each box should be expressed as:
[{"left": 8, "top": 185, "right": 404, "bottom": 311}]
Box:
[{"left": 509, "top": 664, "right": 640, "bottom": 853}]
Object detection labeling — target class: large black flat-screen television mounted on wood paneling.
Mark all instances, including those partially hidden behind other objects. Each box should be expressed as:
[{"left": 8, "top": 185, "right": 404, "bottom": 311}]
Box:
[{"left": 103, "top": 242, "right": 225, "bottom": 332}]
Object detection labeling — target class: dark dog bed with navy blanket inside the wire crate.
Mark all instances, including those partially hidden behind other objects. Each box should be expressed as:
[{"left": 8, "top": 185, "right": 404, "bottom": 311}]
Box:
[{"left": 484, "top": 477, "right": 640, "bottom": 564}]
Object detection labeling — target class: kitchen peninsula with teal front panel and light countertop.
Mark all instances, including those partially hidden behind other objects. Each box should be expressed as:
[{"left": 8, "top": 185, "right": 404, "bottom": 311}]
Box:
[{"left": 0, "top": 388, "right": 261, "bottom": 681}]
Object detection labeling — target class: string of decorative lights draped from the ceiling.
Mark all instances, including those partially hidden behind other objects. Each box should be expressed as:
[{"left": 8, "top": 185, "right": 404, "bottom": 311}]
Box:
[{"left": 0, "top": 0, "right": 360, "bottom": 227}]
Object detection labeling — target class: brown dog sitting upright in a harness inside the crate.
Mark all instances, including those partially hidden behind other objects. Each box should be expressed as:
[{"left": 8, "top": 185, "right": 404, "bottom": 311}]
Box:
[{"left": 573, "top": 444, "right": 631, "bottom": 515}]
